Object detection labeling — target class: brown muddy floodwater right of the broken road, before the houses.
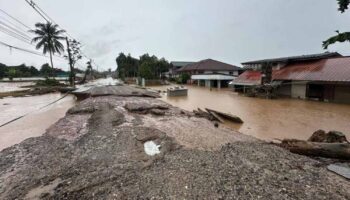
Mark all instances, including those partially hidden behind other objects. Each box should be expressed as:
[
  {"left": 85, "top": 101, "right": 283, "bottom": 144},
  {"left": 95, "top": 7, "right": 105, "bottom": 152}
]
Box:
[{"left": 152, "top": 86, "right": 350, "bottom": 140}]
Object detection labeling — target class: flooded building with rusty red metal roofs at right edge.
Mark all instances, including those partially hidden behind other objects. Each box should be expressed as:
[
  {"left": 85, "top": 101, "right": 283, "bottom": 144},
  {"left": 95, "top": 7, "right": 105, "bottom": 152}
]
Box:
[{"left": 233, "top": 53, "right": 350, "bottom": 103}]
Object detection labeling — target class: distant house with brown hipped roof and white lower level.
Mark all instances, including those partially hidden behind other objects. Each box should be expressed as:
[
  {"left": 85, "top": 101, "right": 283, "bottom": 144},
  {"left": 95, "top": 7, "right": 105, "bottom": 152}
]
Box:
[{"left": 178, "top": 59, "right": 243, "bottom": 88}]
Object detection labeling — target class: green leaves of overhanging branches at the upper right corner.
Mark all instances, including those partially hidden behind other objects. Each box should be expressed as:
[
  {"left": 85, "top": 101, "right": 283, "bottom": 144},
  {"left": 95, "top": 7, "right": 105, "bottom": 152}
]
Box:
[{"left": 322, "top": 0, "right": 350, "bottom": 49}]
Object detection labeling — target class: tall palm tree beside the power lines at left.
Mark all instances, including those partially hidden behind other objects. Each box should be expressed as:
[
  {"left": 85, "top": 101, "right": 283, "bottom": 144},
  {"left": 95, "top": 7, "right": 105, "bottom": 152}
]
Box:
[{"left": 30, "top": 22, "right": 65, "bottom": 77}]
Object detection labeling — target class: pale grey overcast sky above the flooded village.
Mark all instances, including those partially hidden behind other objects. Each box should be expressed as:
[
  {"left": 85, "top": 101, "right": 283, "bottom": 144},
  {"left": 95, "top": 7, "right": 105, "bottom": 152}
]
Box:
[{"left": 0, "top": 0, "right": 350, "bottom": 69}]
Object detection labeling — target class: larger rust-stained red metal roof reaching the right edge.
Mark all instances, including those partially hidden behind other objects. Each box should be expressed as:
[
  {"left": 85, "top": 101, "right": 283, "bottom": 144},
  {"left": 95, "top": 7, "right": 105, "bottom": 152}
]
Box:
[{"left": 273, "top": 57, "right": 350, "bottom": 82}]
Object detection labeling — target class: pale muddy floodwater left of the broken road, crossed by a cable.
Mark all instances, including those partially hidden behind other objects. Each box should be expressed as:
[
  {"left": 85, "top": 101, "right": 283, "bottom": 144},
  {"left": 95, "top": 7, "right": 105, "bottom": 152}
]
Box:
[{"left": 0, "top": 93, "right": 75, "bottom": 151}]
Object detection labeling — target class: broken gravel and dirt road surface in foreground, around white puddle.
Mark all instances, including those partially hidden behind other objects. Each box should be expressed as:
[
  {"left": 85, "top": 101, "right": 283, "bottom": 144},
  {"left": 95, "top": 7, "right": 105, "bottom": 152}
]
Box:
[{"left": 0, "top": 85, "right": 350, "bottom": 199}]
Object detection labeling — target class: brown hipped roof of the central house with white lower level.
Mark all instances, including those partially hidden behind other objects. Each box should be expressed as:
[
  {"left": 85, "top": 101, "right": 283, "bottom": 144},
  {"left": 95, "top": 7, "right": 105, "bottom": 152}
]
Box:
[{"left": 178, "top": 59, "right": 242, "bottom": 72}]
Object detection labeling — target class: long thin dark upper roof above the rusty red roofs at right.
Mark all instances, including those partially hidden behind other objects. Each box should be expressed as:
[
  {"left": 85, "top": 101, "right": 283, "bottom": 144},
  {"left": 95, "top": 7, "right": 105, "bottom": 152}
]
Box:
[{"left": 242, "top": 52, "right": 342, "bottom": 65}]
